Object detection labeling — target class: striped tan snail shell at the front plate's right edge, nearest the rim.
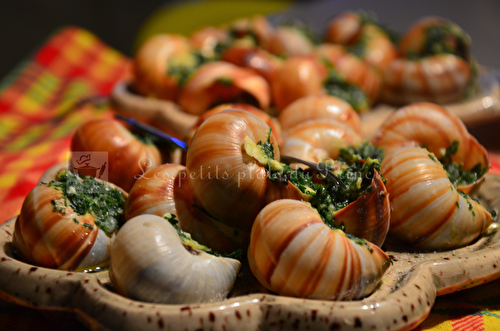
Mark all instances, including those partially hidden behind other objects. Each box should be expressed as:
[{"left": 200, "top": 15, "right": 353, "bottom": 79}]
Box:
[{"left": 381, "top": 147, "right": 492, "bottom": 250}]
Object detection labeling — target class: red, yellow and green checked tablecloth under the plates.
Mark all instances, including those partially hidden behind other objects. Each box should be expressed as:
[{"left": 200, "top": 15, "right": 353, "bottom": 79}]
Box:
[{"left": 0, "top": 27, "right": 500, "bottom": 331}]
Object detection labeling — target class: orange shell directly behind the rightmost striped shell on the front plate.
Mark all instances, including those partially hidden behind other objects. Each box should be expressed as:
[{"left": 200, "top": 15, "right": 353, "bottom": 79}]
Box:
[{"left": 372, "top": 103, "right": 490, "bottom": 193}]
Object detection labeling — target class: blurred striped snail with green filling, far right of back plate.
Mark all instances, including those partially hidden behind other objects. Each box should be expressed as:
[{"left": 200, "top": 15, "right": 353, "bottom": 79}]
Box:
[{"left": 382, "top": 17, "right": 477, "bottom": 105}]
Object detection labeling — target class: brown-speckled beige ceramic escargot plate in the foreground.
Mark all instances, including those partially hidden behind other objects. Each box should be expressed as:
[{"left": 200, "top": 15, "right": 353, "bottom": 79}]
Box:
[{"left": 0, "top": 174, "right": 500, "bottom": 330}]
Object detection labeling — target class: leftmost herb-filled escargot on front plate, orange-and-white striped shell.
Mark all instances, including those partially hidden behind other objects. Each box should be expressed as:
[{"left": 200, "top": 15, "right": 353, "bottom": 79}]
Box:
[{"left": 13, "top": 170, "right": 127, "bottom": 270}]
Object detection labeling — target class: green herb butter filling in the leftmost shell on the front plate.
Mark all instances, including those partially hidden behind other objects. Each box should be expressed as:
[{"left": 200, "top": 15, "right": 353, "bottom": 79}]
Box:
[{"left": 46, "top": 170, "right": 125, "bottom": 235}]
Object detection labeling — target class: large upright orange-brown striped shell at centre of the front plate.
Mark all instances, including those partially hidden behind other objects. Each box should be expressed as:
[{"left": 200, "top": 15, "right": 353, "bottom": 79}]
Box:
[{"left": 186, "top": 110, "right": 302, "bottom": 232}]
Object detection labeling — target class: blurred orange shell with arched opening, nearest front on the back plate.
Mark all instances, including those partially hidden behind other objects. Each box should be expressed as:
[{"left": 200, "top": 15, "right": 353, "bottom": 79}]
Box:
[{"left": 177, "top": 61, "right": 271, "bottom": 115}]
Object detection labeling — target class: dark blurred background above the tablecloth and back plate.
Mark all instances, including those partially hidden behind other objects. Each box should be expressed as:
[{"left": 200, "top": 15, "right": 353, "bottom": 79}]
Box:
[{"left": 0, "top": 0, "right": 500, "bottom": 79}]
